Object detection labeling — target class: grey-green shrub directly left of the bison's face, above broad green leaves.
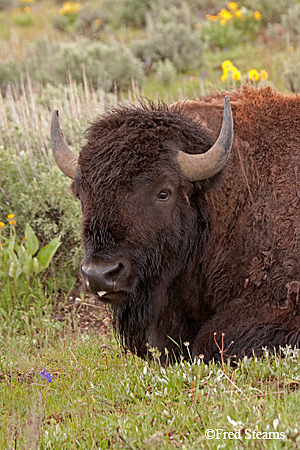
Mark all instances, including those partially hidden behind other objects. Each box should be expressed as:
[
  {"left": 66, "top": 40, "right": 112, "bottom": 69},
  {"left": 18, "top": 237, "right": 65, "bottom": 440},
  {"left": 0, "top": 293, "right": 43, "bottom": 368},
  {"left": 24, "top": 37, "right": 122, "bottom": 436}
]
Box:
[{"left": 0, "top": 147, "right": 81, "bottom": 270}]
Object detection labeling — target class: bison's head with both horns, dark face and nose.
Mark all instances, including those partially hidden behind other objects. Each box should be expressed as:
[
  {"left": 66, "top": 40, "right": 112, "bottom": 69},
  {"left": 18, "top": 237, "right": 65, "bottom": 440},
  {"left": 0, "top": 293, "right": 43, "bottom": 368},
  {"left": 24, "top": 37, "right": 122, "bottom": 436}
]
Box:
[{"left": 51, "top": 97, "right": 233, "bottom": 312}]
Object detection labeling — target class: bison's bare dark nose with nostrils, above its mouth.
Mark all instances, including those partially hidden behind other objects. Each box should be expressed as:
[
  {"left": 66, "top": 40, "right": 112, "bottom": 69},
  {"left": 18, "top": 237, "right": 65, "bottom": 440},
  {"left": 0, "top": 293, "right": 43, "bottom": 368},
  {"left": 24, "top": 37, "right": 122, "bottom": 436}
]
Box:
[{"left": 81, "top": 261, "right": 123, "bottom": 294}]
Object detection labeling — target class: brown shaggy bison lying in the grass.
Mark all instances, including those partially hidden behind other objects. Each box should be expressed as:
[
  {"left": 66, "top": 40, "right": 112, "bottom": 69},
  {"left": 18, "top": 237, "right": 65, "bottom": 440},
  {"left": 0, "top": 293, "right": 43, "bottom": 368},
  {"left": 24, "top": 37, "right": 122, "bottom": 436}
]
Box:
[{"left": 51, "top": 86, "right": 300, "bottom": 361}]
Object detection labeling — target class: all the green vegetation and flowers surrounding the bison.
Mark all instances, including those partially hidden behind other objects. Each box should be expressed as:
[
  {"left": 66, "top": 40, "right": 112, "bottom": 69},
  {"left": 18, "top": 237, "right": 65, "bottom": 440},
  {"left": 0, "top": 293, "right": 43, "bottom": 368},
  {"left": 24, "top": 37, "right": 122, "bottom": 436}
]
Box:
[{"left": 0, "top": 0, "right": 300, "bottom": 449}]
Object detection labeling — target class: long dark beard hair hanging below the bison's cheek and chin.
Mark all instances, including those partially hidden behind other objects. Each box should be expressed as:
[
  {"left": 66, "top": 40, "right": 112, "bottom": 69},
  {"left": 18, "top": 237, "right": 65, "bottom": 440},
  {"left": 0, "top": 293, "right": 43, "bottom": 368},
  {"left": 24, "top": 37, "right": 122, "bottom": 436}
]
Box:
[{"left": 111, "top": 192, "right": 210, "bottom": 360}]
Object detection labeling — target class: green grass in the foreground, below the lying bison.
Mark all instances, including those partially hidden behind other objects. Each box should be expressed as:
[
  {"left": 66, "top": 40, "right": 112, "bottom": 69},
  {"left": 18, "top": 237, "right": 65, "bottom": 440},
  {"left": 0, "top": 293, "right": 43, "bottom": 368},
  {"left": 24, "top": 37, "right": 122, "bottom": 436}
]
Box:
[{"left": 0, "top": 319, "right": 300, "bottom": 449}]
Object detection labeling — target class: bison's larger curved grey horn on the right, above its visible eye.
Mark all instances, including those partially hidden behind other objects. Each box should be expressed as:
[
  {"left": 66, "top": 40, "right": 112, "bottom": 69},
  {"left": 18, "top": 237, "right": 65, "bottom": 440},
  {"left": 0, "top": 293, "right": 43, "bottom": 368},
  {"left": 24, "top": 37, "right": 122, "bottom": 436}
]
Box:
[{"left": 177, "top": 95, "right": 233, "bottom": 181}]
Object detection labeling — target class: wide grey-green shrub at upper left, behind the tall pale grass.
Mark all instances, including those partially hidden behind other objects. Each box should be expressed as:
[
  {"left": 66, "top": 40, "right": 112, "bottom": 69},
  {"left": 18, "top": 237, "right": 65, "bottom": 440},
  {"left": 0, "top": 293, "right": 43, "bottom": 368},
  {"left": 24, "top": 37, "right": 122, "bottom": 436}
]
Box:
[{"left": 0, "top": 39, "right": 144, "bottom": 92}]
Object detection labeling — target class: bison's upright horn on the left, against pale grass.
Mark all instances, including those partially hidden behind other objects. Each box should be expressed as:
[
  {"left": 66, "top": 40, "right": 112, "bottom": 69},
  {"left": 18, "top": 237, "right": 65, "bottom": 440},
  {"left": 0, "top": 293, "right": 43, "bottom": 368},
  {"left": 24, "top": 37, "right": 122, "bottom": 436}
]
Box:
[{"left": 51, "top": 110, "right": 78, "bottom": 180}]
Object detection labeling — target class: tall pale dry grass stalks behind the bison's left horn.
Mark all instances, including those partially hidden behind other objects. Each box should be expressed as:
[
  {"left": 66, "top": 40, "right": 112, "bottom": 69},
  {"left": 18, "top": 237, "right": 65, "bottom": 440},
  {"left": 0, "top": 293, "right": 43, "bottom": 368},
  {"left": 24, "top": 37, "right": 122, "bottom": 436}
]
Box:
[{"left": 0, "top": 75, "right": 144, "bottom": 174}]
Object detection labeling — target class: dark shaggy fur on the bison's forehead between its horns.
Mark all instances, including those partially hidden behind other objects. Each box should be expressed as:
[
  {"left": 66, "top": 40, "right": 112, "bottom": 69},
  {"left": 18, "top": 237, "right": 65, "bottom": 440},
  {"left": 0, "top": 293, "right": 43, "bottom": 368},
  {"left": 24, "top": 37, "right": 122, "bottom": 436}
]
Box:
[{"left": 79, "top": 103, "right": 213, "bottom": 198}]
